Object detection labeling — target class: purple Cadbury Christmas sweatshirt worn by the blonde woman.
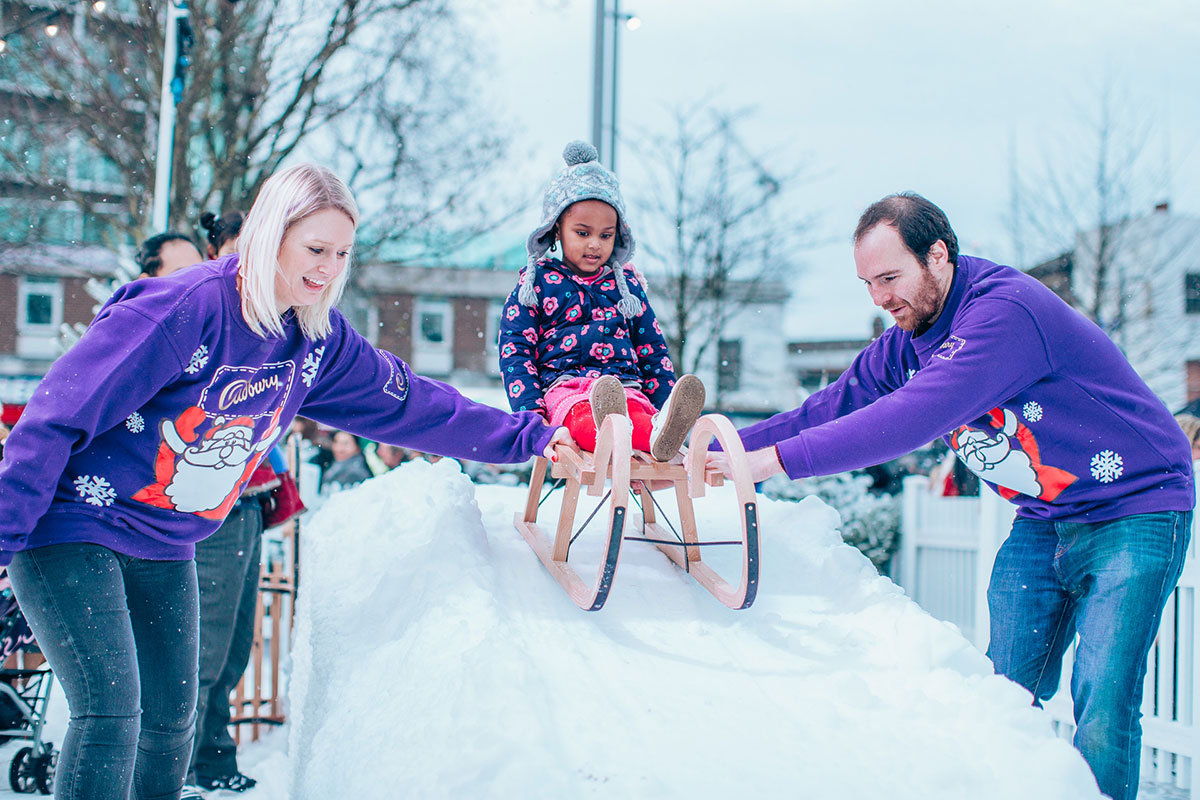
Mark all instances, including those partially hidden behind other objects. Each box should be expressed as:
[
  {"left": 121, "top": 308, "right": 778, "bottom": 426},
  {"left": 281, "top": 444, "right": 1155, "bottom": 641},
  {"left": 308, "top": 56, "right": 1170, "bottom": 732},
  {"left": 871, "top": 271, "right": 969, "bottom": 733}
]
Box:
[{"left": 0, "top": 255, "right": 553, "bottom": 564}]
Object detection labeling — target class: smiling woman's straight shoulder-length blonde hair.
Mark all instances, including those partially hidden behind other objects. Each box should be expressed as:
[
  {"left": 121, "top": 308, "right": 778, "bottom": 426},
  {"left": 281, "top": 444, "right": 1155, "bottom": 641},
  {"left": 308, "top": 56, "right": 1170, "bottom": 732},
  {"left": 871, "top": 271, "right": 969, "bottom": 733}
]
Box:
[{"left": 238, "top": 164, "right": 359, "bottom": 339}]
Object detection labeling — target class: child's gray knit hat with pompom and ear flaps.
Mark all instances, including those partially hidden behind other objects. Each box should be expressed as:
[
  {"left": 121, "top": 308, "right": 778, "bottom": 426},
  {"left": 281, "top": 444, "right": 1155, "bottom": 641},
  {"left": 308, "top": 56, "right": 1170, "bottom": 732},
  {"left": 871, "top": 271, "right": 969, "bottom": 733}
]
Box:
[{"left": 517, "top": 139, "right": 642, "bottom": 319}]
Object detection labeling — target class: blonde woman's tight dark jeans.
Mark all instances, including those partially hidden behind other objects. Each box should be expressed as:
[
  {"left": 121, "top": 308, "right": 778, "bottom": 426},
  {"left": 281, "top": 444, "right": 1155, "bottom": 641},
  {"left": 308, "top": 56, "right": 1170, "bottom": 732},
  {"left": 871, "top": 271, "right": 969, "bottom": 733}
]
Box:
[{"left": 8, "top": 545, "right": 199, "bottom": 800}]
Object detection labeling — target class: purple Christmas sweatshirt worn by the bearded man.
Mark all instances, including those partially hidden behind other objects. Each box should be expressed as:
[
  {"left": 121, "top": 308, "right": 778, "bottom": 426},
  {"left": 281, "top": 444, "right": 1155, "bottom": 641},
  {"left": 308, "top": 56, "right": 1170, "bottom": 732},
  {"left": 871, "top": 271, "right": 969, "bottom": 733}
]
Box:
[{"left": 740, "top": 255, "right": 1195, "bottom": 522}]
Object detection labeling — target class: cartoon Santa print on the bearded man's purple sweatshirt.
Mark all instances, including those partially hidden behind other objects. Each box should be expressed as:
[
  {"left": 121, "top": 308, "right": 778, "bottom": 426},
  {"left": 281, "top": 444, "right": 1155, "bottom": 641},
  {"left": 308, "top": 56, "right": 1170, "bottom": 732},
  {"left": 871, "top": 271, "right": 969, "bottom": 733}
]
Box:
[{"left": 950, "top": 408, "right": 1078, "bottom": 501}]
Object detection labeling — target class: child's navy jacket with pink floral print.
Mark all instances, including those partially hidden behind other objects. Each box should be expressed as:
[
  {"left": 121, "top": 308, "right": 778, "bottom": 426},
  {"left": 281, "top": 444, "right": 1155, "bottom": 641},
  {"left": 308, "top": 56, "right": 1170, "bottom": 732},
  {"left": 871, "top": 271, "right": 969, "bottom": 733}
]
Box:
[{"left": 499, "top": 258, "right": 676, "bottom": 411}]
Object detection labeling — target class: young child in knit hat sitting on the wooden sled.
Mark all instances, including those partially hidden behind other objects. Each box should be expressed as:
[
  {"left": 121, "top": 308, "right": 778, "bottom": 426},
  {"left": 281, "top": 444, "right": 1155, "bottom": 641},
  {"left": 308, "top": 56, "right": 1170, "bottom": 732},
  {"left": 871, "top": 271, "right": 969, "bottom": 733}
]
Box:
[{"left": 499, "top": 142, "right": 704, "bottom": 462}]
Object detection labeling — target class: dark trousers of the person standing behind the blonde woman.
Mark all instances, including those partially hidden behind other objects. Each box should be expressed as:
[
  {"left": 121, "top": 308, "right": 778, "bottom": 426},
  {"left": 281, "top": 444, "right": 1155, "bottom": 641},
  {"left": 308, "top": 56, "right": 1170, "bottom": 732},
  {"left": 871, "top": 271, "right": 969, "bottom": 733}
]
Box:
[{"left": 188, "top": 499, "right": 263, "bottom": 780}]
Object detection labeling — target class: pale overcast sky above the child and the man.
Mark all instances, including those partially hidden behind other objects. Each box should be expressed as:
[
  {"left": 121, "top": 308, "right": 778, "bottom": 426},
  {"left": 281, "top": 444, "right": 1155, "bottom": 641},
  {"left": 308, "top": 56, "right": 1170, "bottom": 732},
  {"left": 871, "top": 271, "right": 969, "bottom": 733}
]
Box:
[{"left": 460, "top": 0, "right": 1200, "bottom": 338}]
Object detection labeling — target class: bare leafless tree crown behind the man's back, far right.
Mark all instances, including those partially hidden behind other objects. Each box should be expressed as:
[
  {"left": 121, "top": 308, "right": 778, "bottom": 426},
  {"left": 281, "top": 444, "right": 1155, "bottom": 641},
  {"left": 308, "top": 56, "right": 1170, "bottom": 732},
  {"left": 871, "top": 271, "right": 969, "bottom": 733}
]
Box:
[{"left": 1009, "top": 80, "right": 1200, "bottom": 404}]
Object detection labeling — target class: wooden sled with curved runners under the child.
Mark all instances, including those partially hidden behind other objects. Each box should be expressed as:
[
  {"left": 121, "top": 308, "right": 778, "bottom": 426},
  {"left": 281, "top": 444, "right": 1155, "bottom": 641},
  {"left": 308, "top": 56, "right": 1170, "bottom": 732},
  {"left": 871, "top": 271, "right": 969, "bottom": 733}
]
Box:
[{"left": 514, "top": 414, "right": 760, "bottom": 612}]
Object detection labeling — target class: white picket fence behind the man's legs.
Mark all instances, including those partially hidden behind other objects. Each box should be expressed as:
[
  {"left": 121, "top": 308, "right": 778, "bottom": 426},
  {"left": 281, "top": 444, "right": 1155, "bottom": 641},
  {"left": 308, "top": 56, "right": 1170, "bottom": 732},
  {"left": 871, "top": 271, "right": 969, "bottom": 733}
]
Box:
[{"left": 892, "top": 476, "right": 1200, "bottom": 800}]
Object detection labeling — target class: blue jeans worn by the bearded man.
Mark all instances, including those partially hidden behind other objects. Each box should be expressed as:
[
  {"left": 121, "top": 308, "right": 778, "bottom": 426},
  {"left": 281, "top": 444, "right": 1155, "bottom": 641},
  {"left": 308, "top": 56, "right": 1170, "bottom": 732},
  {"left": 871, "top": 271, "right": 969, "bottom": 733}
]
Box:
[{"left": 988, "top": 511, "right": 1192, "bottom": 800}]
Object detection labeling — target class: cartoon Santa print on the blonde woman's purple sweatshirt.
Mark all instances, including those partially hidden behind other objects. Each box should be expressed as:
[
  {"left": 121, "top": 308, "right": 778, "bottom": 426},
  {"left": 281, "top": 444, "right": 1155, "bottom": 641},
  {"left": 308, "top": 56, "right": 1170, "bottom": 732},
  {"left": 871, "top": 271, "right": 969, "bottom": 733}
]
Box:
[{"left": 133, "top": 405, "right": 283, "bottom": 519}]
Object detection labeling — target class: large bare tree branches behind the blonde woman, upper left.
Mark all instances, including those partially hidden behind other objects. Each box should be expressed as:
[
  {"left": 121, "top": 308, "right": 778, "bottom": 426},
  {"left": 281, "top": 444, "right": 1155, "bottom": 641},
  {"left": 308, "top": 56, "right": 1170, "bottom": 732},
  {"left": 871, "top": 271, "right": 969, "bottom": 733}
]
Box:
[{"left": 0, "top": 0, "right": 506, "bottom": 260}]
